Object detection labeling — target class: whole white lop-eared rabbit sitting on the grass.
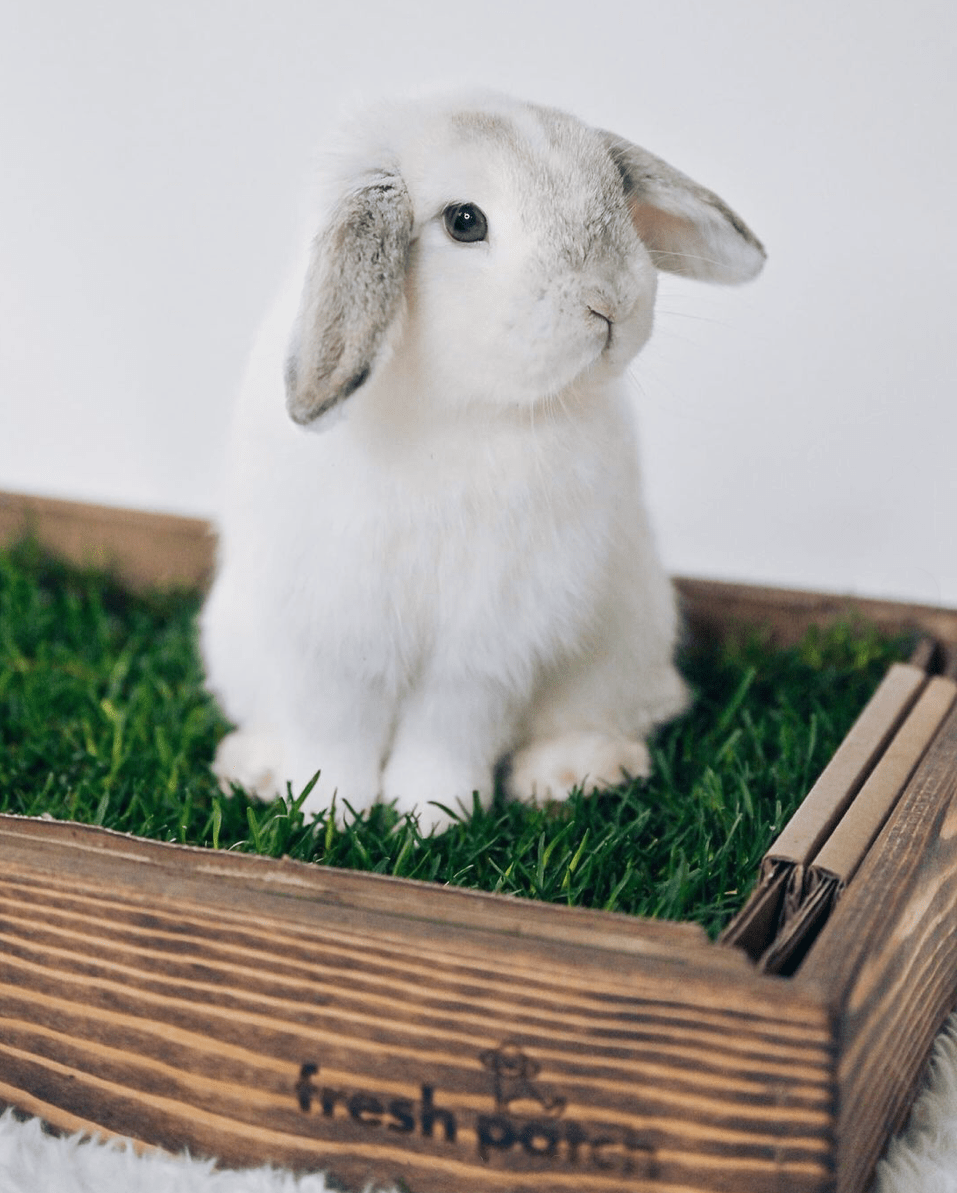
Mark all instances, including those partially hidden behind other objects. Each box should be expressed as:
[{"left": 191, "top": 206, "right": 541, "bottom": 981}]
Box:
[{"left": 200, "top": 93, "right": 764, "bottom": 828}]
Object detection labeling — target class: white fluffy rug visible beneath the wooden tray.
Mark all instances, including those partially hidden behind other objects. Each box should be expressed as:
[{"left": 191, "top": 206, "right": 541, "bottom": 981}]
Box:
[{"left": 0, "top": 1014, "right": 957, "bottom": 1193}]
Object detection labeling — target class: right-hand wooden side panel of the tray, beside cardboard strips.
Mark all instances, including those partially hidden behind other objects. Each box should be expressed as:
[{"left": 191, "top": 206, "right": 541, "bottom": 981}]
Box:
[{"left": 796, "top": 710, "right": 957, "bottom": 1193}]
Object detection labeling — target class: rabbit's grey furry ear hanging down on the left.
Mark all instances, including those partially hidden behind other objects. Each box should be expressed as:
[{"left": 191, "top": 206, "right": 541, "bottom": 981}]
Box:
[{"left": 285, "top": 171, "right": 413, "bottom": 425}]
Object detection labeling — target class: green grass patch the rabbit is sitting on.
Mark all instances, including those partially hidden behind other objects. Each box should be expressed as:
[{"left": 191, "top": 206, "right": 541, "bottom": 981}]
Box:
[{"left": 0, "top": 542, "right": 906, "bottom": 933}]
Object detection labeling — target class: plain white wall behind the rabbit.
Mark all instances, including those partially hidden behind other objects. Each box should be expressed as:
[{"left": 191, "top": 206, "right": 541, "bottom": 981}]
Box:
[{"left": 0, "top": 0, "right": 957, "bottom": 605}]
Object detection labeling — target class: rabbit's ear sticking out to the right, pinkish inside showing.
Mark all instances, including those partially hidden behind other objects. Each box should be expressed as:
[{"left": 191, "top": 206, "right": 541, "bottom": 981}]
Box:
[{"left": 601, "top": 132, "right": 765, "bottom": 283}]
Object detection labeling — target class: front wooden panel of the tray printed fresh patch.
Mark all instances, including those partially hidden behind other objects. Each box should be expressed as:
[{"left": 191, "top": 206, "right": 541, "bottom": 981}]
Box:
[{"left": 0, "top": 818, "right": 834, "bottom": 1193}]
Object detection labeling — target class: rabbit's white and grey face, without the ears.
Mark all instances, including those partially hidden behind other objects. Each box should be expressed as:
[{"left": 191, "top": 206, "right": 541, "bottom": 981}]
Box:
[{"left": 399, "top": 107, "right": 656, "bottom": 404}]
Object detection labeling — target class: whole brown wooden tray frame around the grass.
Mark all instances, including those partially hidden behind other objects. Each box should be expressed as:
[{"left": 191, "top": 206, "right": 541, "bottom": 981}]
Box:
[{"left": 0, "top": 494, "right": 957, "bottom": 1193}]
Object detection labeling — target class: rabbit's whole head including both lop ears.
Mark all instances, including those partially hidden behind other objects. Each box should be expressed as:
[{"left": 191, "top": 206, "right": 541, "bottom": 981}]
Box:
[{"left": 286, "top": 94, "right": 764, "bottom": 425}]
